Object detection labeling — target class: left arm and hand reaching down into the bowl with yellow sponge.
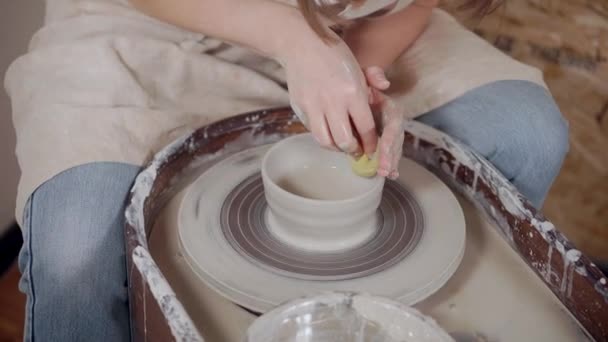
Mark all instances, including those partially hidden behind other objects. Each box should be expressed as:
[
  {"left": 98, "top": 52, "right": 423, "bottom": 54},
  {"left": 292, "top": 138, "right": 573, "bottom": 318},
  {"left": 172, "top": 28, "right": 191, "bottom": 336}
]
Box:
[{"left": 129, "top": 0, "right": 378, "bottom": 154}]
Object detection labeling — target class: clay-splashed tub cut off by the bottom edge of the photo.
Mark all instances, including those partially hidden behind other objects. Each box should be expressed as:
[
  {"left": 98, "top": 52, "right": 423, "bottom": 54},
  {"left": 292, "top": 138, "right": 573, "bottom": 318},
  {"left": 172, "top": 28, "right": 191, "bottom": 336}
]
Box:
[{"left": 245, "top": 293, "right": 453, "bottom": 342}]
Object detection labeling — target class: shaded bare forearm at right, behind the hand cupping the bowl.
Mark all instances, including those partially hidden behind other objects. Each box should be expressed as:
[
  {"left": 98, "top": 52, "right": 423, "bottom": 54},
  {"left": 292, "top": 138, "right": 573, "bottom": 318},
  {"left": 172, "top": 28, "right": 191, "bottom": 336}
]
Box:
[{"left": 344, "top": 0, "right": 438, "bottom": 69}]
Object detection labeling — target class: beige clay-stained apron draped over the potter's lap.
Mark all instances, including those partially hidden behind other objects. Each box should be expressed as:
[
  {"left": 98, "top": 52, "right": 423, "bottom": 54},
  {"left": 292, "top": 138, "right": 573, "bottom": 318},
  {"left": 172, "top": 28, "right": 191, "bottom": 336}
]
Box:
[{"left": 5, "top": 0, "right": 544, "bottom": 222}]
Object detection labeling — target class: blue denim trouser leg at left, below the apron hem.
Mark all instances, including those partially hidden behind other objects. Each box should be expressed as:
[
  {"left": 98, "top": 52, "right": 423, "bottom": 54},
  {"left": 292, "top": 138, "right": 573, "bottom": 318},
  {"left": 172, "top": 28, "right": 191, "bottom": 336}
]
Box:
[{"left": 19, "top": 163, "right": 140, "bottom": 342}]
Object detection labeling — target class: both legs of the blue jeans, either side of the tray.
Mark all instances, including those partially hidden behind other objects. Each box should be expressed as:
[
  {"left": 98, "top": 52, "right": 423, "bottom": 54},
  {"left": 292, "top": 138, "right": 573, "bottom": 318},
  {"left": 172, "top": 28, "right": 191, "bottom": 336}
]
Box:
[{"left": 19, "top": 81, "right": 568, "bottom": 341}]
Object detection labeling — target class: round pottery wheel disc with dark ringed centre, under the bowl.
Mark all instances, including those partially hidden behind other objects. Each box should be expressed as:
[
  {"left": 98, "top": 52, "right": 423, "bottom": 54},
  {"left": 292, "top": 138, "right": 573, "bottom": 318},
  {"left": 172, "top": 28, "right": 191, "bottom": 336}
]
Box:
[{"left": 178, "top": 140, "right": 465, "bottom": 312}]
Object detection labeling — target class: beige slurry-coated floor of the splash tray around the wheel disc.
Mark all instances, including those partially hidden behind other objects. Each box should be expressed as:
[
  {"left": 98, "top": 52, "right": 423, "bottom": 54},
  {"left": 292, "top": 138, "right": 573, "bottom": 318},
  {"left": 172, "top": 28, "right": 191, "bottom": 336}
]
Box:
[{"left": 150, "top": 192, "right": 586, "bottom": 342}]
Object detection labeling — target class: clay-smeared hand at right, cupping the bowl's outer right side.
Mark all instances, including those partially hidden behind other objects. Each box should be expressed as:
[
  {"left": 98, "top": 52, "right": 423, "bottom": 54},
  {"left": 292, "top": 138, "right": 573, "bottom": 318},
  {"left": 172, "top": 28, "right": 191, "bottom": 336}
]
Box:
[{"left": 364, "top": 67, "right": 405, "bottom": 179}]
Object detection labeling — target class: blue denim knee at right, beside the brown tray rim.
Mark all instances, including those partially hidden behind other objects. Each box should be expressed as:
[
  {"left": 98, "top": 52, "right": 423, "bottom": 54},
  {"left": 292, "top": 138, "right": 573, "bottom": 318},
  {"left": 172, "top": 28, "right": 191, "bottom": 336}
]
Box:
[{"left": 418, "top": 81, "right": 569, "bottom": 208}]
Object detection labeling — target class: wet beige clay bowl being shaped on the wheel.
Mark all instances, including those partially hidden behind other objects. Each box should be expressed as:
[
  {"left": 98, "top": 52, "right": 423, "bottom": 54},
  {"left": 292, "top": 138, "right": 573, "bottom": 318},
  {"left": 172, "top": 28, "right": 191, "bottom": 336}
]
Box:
[{"left": 262, "top": 133, "right": 384, "bottom": 252}]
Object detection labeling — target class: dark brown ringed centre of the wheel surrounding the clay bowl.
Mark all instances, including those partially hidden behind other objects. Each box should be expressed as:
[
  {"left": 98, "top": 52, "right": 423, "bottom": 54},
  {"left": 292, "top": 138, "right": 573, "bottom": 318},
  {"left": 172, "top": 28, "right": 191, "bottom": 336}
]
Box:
[{"left": 221, "top": 175, "right": 424, "bottom": 281}]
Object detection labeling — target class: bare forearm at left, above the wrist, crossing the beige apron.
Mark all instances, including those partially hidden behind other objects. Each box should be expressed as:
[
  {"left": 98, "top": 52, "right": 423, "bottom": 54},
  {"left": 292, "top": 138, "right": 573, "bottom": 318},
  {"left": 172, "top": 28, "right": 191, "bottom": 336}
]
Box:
[{"left": 129, "top": 0, "right": 314, "bottom": 58}]
